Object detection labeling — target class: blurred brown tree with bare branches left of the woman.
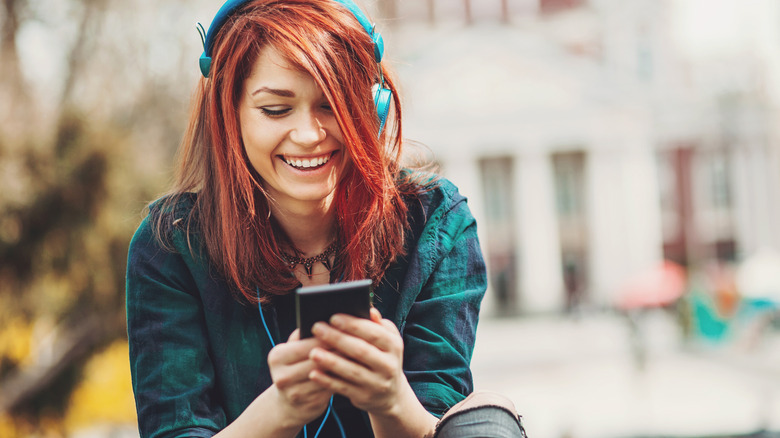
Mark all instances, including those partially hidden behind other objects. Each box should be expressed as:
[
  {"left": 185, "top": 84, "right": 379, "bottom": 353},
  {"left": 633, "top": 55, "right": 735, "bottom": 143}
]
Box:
[{"left": 0, "top": 0, "right": 194, "bottom": 434}]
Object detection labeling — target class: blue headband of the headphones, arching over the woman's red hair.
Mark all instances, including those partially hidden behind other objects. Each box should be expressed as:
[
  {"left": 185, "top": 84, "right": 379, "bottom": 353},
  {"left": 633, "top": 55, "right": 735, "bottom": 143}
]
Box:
[{"left": 198, "top": 0, "right": 385, "bottom": 78}]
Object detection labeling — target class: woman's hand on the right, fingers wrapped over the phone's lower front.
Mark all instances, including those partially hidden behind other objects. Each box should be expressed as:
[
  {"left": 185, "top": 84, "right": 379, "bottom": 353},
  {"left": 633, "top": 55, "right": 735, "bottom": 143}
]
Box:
[{"left": 309, "top": 308, "right": 411, "bottom": 415}]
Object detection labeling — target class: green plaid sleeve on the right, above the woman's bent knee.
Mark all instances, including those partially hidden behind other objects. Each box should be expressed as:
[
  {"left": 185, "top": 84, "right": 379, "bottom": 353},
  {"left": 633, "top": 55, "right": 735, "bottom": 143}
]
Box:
[{"left": 400, "top": 182, "right": 487, "bottom": 416}]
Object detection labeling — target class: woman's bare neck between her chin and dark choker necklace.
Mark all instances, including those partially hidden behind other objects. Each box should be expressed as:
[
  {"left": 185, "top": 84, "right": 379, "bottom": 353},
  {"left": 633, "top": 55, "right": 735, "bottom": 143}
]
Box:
[{"left": 271, "top": 197, "right": 336, "bottom": 257}]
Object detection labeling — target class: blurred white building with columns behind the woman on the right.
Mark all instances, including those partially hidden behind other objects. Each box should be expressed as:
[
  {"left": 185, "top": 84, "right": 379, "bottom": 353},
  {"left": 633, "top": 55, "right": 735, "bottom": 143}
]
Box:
[{"left": 376, "top": 0, "right": 780, "bottom": 315}]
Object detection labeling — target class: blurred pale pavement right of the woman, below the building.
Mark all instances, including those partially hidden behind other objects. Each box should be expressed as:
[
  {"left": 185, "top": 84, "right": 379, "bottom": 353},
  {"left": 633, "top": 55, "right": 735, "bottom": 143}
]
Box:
[{"left": 472, "top": 311, "right": 780, "bottom": 438}]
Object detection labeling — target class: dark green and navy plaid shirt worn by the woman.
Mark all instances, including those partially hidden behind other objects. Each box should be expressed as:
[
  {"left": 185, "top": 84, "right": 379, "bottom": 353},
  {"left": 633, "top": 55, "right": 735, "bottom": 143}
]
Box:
[{"left": 126, "top": 179, "right": 487, "bottom": 437}]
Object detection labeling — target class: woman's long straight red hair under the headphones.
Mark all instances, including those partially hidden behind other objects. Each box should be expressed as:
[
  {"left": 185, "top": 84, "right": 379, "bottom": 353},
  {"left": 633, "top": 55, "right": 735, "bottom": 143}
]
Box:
[{"left": 157, "top": 0, "right": 413, "bottom": 302}]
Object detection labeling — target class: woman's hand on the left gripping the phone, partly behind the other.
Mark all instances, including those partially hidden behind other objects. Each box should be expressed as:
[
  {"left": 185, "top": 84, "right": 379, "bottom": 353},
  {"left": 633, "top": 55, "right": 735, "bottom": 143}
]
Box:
[{"left": 268, "top": 330, "right": 333, "bottom": 426}]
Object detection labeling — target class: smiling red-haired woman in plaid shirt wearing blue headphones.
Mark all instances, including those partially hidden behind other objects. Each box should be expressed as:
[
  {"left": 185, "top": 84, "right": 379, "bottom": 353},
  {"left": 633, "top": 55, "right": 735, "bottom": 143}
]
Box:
[{"left": 127, "top": 0, "right": 522, "bottom": 437}]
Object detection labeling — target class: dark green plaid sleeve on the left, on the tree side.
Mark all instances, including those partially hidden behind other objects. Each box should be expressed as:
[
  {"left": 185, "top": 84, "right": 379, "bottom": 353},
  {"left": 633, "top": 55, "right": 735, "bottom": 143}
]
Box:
[{"left": 126, "top": 217, "right": 225, "bottom": 437}]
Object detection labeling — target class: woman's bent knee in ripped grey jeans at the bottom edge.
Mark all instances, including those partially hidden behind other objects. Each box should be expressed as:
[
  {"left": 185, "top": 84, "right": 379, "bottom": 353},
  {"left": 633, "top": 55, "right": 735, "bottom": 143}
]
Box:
[{"left": 434, "top": 393, "right": 526, "bottom": 438}]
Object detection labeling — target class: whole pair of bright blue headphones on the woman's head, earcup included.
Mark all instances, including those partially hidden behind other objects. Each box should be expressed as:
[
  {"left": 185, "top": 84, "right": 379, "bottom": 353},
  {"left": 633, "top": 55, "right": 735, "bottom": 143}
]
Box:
[{"left": 198, "top": 0, "right": 393, "bottom": 134}]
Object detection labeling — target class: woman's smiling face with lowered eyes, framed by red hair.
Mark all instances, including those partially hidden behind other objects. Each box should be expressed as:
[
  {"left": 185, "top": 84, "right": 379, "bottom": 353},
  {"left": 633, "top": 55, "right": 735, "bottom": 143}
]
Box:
[{"left": 239, "top": 46, "right": 348, "bottom": 216}]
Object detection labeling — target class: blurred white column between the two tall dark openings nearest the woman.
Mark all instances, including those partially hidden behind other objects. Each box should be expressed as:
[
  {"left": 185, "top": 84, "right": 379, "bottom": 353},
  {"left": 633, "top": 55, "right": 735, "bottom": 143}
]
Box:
[{"left": 517, "top": 152, "right": 565, "bottom": 313}]
